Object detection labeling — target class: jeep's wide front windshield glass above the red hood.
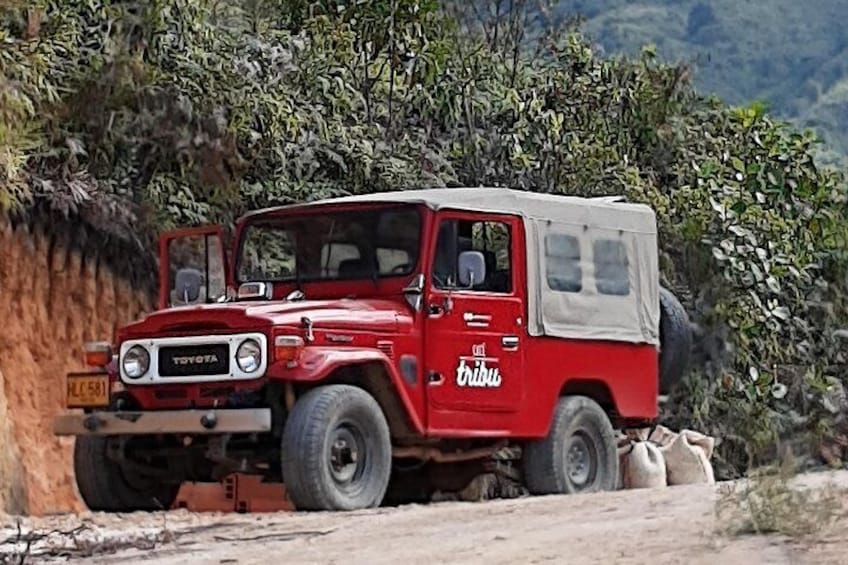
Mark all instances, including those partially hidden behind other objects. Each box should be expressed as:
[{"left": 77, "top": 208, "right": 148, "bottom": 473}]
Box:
[{"left": 237, "top": 206, "right": 421, "bottom": 282}]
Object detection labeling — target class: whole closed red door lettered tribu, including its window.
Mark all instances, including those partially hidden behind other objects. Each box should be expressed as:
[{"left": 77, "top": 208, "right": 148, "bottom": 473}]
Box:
[{"left": 424, "top": 212, "right": 524, "bottom": 429}]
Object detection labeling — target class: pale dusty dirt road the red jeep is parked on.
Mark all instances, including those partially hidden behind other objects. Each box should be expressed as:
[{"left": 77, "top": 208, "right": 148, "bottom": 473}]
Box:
[{"left": 0, "top": 472, "right": 848, "bottom": 565}]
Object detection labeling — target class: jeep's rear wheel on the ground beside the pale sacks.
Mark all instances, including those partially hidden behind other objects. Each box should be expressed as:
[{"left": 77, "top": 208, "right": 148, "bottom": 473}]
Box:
[{"left": 522, "top": 396, "right": 618, "bottom": 495}]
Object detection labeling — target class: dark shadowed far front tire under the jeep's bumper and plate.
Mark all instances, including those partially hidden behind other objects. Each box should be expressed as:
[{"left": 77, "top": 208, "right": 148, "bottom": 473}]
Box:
[{"left": 74, "top": 436, "right": 180, "bottom": 512}]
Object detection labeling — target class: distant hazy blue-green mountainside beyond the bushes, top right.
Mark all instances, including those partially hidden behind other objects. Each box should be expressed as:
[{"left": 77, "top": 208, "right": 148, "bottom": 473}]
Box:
[{"left": 554, "top": 0, "right": 848, "bottom": 159}]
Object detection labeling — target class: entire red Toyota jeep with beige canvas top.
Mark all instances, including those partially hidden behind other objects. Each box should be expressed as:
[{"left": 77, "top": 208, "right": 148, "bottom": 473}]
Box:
[{"left": 55, "top": 188, "right": 691, "bottom": 511}]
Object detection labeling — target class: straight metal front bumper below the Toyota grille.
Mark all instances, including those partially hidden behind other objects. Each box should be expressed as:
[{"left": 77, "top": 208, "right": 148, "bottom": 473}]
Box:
[{"left": 53, "top": 408, "right": 271, "bottom": 436}]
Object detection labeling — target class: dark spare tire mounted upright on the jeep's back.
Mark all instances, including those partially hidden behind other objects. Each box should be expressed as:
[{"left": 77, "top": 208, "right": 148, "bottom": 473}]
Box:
[{"left": 659, "top": 287, "right": 692, "bottom": 394}]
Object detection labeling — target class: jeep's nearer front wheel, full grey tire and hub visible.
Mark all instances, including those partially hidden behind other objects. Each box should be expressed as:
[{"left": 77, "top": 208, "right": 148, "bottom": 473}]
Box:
[{"left": 282, "top": 385, "right": 392, "bottom": 510}]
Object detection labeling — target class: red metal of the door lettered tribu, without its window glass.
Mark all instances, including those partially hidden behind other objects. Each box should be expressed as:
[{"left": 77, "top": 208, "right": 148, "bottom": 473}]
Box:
[{"left": 424, "top": 209, "right": 527, "bottom": 435}]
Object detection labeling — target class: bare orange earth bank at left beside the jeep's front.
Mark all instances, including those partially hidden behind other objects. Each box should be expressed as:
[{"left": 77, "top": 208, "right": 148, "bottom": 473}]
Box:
[{"left": 0, "top": 219, "right": 149, "bottom": 514}]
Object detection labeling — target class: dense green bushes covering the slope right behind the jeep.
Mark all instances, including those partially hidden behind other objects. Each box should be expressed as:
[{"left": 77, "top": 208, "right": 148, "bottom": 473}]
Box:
[{"left": 0, "top": 0, "right": 846, "bottom": 476}]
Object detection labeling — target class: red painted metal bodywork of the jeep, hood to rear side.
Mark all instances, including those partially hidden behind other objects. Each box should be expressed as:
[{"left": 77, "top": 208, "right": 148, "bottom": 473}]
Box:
[{"left": 114, "top": 200, "right": 658, "bottom": 438}]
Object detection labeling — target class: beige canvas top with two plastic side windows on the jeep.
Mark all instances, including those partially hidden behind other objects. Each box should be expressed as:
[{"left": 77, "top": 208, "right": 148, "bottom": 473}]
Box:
[{"left": 251, "top": 188, "right": 660, "bottom": 345}]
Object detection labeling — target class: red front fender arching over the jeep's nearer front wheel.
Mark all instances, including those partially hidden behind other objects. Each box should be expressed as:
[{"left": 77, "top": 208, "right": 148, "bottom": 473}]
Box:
[{"left": 267, "top": 347, "right": 424, "bottom": 438}]
